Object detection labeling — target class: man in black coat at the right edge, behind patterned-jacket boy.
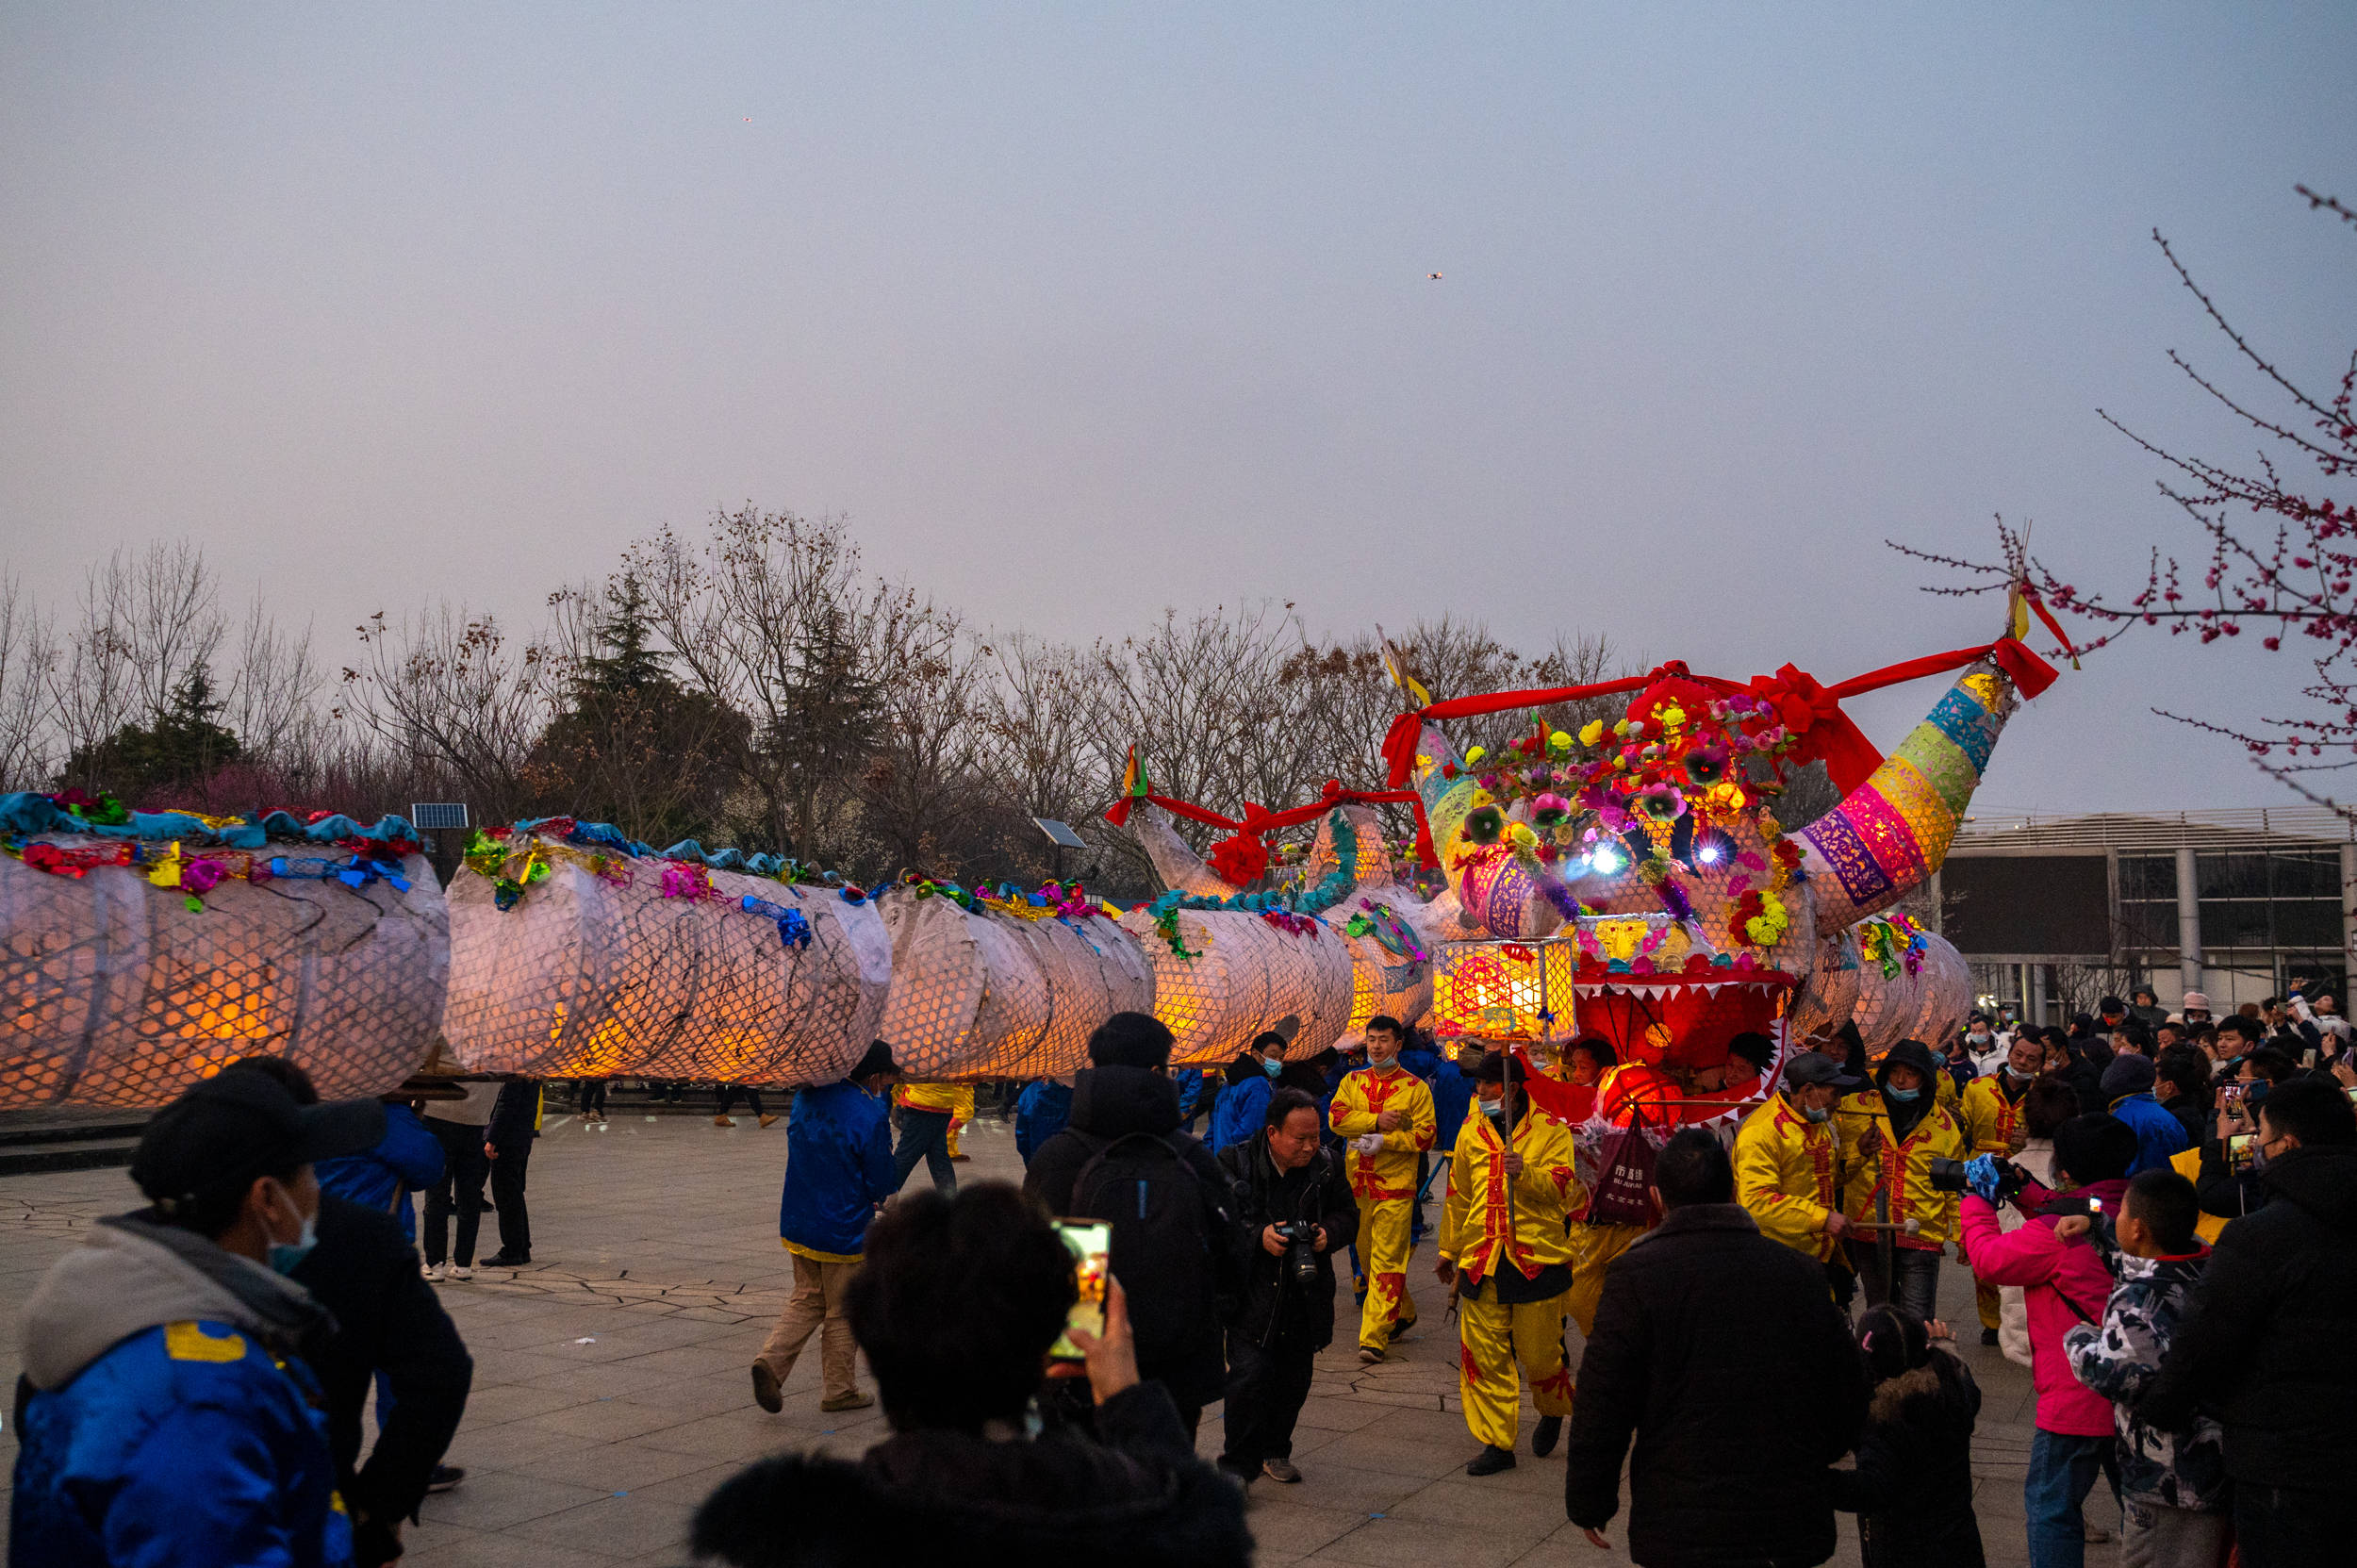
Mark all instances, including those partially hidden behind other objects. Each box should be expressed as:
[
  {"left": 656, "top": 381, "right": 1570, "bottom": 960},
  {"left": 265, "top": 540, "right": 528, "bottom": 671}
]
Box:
[{"left": 2135, "top": 1078, "right": 2357, "bottom": 1568}]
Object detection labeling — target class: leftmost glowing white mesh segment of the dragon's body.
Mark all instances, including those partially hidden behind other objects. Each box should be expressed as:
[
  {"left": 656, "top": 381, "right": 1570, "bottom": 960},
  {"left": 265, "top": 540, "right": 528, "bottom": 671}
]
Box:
[{"left": 0, "top": 834, "right": 451, "bottom": 1108}]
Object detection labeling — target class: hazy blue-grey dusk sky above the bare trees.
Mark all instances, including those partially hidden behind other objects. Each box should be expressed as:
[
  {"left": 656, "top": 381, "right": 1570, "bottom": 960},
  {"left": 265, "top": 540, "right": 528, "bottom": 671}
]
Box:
[{"left": 0, "top": 0, "right": 2357, "bottom": 811}]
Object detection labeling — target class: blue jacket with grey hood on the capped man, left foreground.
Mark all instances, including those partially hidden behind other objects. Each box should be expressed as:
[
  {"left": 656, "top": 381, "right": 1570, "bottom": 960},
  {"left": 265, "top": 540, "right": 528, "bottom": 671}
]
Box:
[{"left": 9, "top": 1221, "right": 352, "bottom": 1568}]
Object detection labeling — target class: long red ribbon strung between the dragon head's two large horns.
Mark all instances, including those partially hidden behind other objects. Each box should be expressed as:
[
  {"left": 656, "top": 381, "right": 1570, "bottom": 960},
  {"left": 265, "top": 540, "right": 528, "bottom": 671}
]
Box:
[{"left": 1384, "top": 636, "right": 2069, "bottom": 795}]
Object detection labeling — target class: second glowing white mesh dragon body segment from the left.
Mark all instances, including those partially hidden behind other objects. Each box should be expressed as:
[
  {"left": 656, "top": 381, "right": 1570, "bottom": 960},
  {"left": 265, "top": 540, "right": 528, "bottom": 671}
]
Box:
[{"left": 443, "top": 842, "right": 891, "bottom": 1084}]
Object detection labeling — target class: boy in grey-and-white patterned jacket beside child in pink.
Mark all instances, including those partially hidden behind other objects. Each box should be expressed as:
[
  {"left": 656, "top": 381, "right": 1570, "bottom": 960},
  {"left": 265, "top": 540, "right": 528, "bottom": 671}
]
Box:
[{"left": 2055, "top": 1164, "right": 2230, "bottom": 1568}]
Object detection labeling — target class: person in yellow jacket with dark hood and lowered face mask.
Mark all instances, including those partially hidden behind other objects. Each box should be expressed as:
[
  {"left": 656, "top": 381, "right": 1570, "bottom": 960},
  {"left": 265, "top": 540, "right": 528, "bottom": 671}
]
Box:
[{"left": 1834, "top": 1040, "right": 1966, "bottom": 1320}]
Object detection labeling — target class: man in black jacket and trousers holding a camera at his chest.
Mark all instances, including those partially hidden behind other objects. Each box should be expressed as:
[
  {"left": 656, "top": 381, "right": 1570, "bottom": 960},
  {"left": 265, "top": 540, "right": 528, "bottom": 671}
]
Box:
[{"left": 1219, "top": 1087, "right": 1358, "bottom": 1485}]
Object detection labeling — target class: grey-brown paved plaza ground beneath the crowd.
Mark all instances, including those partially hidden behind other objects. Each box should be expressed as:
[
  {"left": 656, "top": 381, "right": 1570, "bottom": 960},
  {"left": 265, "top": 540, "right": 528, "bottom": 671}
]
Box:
[{"left": 0, "top": 1113, "right": 2119, "bottom": 1568}]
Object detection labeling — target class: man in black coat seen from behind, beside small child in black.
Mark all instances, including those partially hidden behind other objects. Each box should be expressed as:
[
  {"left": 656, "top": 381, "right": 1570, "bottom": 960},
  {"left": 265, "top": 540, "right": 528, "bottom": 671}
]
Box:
[{"left": 1563, "top": 1127, "right": 1867, "bottom": 1568}]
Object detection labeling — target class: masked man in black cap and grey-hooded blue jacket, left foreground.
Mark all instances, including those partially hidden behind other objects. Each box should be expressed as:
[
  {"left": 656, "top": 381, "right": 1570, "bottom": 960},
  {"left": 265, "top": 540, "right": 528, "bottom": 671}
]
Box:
[{"left": 9, "top": 1068, "right": 385, "bottom": 1568}]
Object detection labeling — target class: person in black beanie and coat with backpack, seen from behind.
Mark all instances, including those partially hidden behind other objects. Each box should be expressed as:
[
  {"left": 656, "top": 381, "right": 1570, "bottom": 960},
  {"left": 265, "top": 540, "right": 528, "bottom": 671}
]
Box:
[{"left": 1023, "top": 1012, "right": 1235, "bottom": 1433}]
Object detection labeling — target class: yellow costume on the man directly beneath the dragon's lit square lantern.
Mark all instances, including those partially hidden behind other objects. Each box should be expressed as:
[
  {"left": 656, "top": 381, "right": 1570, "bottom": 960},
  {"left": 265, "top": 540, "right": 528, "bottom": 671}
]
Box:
[{"left": 1441, "top": 1101, "right": 1587, "bottom": 1450}]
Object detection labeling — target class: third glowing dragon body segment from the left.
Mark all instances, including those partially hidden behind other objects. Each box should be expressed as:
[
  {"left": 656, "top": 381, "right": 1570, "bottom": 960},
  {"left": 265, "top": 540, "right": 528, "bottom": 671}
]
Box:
[{"left": 882, "top": 889, "right": 1155, "bottom": 1082}]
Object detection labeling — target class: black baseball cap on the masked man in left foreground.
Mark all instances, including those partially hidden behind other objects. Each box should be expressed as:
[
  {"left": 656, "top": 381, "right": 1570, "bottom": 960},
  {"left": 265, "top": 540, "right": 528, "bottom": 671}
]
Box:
[{"left": 132, "top": 1065, "right": 385, "bottom": 1207}]
